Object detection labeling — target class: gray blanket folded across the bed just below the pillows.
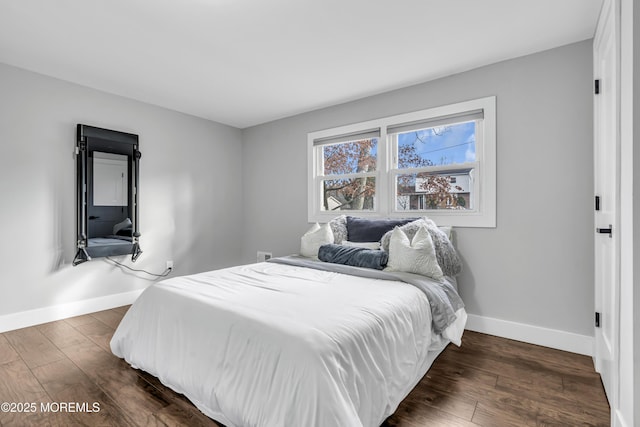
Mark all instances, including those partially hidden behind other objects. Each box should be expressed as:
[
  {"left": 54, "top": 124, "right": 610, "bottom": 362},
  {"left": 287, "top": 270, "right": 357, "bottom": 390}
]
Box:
[{"left": 268, "top": 255, "right": 464, "bottom": 334}]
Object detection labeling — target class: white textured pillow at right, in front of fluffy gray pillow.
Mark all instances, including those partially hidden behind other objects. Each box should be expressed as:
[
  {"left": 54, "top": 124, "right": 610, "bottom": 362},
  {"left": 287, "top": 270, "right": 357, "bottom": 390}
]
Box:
[{"left": 385, "top": 226, "right": 443, "bottom": 280}]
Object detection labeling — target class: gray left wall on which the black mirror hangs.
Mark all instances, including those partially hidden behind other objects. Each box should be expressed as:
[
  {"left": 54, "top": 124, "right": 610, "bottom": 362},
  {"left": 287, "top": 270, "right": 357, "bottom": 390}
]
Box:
[{"left": 0, "top": 64, "right": 242, "bottom": 315}]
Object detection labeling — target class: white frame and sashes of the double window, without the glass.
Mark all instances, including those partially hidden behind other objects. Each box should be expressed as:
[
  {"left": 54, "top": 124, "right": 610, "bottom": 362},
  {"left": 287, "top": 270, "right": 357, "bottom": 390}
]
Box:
[{"left": 307, "top": 96, "right": 497, "bottom": 228}]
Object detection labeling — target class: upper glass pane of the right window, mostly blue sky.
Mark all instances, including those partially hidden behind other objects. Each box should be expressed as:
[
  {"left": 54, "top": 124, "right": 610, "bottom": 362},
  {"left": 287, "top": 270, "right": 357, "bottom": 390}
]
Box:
[{"left": 397, "top": 121, "right": 476, "bottom": 169}]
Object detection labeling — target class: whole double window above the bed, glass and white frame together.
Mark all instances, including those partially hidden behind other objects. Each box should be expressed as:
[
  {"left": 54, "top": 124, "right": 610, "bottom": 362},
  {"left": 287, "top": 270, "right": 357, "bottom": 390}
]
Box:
[{"left": 308, "top": 97, "right": 496, "bottom": 227}]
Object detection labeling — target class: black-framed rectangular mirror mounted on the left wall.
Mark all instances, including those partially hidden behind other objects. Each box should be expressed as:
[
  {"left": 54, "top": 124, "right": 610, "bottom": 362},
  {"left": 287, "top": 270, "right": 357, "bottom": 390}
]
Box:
[{"left": 73, "top": 124, "right": 142, "bottom": 266}]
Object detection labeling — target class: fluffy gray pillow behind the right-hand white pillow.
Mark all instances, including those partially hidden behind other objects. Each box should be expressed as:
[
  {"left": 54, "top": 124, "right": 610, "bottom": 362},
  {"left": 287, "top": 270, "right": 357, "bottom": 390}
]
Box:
[{"left": 380, "top": 218, "right": 462, "bottom": 276}]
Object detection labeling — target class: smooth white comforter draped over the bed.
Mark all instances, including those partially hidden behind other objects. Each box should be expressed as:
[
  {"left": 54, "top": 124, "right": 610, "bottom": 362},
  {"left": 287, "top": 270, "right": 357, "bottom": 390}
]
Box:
[{"left": 111, "top": 263, "right": 461, "bottom": 427}]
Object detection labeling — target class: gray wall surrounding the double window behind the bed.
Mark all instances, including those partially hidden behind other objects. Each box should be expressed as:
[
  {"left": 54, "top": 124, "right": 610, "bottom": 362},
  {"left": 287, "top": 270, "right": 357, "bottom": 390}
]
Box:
[{"left": 242, "top": 40, "right": 594, "bottom": 336}]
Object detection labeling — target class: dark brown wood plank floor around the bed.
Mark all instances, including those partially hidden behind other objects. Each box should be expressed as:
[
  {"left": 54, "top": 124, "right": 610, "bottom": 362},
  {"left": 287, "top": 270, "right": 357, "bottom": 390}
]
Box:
[{"left": 0, "top": 307, "right": 609, "bottom": 427}]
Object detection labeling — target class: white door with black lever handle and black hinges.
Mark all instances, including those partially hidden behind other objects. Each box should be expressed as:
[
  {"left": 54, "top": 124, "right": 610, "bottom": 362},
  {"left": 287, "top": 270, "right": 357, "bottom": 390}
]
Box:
[{"left": 593, "top": 0, "right": 620, "bottom": 407}]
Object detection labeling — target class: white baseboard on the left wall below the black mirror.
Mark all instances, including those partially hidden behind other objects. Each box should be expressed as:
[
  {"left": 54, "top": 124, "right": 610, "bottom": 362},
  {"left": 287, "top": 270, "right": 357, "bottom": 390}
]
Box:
[{"left": 0, "top": 289, "right": 144, "bottom": 333}]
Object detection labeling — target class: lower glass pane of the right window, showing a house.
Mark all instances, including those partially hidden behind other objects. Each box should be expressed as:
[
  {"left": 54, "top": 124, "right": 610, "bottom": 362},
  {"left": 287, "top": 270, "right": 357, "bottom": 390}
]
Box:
[{"left": 396, "top": 170, "right": 473, "bottom": 211}]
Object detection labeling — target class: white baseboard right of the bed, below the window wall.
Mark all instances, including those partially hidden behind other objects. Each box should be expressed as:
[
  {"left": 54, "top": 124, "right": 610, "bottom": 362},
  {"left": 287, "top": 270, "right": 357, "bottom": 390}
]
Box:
[{"left": 465, "top": 314, "right": 594, "bottom": 356}]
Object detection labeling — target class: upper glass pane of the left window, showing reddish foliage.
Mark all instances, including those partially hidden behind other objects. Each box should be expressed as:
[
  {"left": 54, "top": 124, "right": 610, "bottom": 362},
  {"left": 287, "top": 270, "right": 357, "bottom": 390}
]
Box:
[{"left": 321, "top": 138, "right": 378, "bottom": 175}]
